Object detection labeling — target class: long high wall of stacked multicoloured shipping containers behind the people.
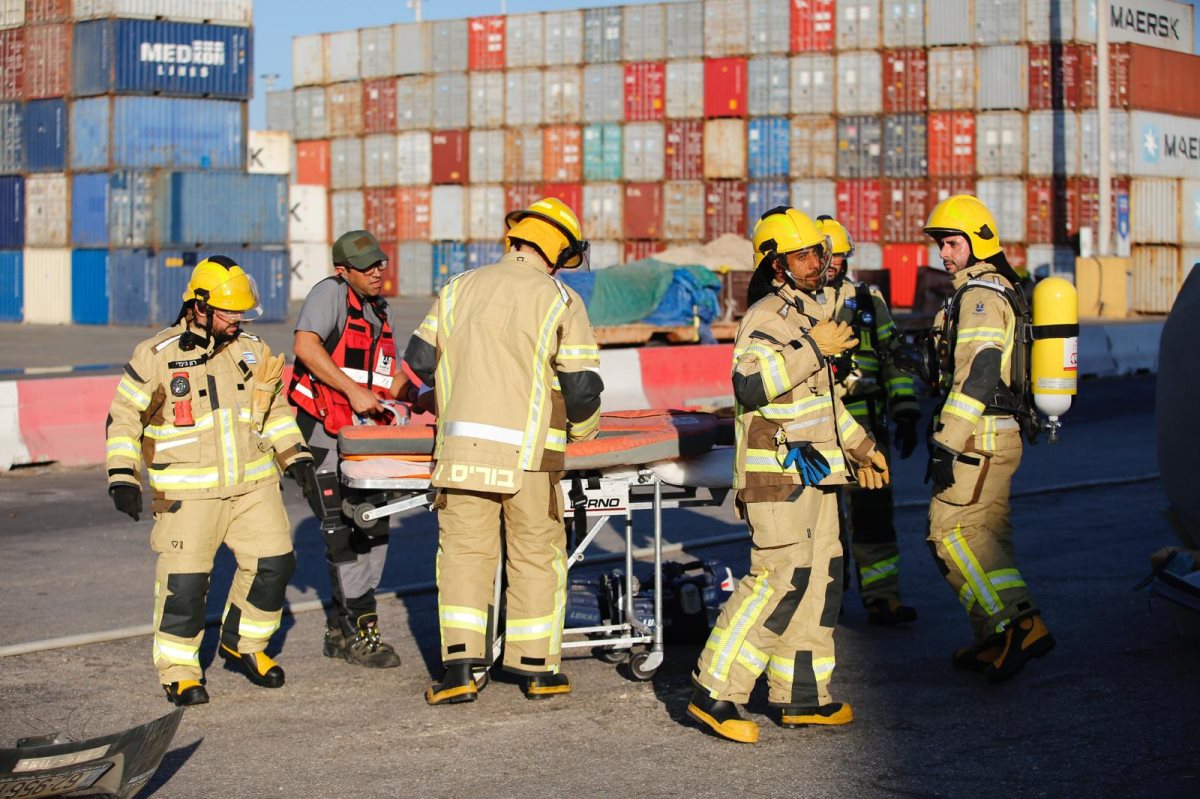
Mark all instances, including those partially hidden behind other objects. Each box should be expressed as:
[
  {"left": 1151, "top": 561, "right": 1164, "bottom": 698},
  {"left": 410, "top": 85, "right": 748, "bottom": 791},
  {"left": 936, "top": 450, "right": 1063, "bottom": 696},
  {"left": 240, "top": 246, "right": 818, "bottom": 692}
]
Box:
[{"left": 269, "top": 0, "right": 1200, "bottom": 311}]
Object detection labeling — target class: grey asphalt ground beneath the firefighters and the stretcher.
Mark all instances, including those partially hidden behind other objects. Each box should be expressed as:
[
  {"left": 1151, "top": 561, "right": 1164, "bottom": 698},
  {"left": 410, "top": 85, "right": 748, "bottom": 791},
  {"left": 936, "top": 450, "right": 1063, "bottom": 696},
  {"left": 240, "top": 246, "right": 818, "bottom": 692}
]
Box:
[{"left": 0, "top": 377, "right": 1200, "bottom": 798}]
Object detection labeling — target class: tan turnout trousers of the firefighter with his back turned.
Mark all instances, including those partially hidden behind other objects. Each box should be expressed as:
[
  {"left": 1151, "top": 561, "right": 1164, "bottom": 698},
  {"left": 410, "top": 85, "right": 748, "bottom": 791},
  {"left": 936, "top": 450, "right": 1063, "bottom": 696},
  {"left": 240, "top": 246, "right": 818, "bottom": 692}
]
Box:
[{"left": 434, "top": 471, "right": 566, "bottom": 675}]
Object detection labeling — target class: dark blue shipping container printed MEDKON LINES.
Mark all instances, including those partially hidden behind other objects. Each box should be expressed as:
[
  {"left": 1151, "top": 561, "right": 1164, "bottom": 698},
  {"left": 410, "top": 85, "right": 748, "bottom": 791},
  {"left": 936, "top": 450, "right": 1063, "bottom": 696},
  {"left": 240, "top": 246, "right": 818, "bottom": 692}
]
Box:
[{"left": 72, "top": 19, "right": 252, "bottom": 100}]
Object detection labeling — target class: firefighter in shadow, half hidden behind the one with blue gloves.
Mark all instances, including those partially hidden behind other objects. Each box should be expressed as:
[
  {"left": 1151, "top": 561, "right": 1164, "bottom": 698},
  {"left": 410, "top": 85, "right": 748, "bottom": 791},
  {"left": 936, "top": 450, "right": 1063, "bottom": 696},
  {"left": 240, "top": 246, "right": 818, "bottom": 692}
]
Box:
[{"left": 817, "top": 216, "right": 920, "bottom": 626}]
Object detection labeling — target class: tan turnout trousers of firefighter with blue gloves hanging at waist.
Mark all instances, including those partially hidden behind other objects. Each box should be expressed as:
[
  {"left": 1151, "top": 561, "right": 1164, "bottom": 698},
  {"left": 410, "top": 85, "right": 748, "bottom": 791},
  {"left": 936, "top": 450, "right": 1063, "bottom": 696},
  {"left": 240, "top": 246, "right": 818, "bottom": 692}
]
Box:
[{"left": 692, "top": 486, "right": 842, "bottom": 708}]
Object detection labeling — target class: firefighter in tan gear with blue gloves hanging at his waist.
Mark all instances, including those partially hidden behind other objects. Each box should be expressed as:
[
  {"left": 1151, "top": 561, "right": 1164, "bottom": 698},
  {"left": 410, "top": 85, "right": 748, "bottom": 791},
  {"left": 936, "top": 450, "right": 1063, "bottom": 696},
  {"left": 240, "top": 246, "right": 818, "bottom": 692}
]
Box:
[{"left": 688, "top": 208, "right": 889, "bottom": 743}]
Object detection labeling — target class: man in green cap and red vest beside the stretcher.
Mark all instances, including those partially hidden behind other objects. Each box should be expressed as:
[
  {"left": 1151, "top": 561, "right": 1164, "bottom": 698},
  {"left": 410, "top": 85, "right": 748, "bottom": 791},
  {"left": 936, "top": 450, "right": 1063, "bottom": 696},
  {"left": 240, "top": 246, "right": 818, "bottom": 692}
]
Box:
[{"left": 288, "top": 230, "right": 408, "bottom": 668}]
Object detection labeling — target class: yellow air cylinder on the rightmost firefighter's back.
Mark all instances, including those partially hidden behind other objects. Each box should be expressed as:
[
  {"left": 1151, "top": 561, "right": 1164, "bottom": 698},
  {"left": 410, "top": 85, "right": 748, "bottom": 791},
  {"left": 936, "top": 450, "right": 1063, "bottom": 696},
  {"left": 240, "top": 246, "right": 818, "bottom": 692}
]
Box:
[{"left": 1031, "top": 277, "right": 1079, "bottom": 425}]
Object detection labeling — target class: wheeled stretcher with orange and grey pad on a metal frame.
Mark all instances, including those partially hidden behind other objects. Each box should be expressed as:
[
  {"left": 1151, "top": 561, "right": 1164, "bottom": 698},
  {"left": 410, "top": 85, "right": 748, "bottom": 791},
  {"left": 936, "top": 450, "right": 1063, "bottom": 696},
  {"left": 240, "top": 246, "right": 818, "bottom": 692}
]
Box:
[{"left": 338, "top": 410, "right": 733, "bottom": 680}]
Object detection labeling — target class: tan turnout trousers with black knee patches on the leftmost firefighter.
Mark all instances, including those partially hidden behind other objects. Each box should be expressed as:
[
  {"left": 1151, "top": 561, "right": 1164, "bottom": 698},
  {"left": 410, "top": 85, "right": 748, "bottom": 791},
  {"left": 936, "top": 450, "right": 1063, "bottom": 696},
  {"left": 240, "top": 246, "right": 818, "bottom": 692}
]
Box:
[{"left": 150, "top": 480, "right": 296, "bottom": 684}]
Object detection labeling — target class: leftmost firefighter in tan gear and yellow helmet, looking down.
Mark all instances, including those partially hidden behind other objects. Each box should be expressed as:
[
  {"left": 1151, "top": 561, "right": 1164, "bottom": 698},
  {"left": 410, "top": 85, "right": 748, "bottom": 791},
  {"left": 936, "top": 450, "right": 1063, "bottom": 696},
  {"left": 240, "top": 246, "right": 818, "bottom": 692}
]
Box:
[{"left": 106, "top": 256, "right": 312, "bottom": 705}]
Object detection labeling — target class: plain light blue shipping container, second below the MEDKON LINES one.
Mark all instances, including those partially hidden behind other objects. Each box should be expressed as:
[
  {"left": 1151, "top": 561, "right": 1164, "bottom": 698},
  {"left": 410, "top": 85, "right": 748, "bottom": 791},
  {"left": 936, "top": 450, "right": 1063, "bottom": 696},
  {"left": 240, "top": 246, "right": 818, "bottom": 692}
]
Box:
[{"left": 154, "top": 172, "right": 288, "bottom": 247}]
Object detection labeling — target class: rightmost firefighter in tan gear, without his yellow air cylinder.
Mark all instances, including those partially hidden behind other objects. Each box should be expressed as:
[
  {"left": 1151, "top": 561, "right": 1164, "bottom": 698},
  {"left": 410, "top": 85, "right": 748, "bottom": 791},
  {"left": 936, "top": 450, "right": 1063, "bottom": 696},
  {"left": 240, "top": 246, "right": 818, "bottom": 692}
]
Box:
[{"left": 925, "top": 194, "right": 1055, "bottom": 683}]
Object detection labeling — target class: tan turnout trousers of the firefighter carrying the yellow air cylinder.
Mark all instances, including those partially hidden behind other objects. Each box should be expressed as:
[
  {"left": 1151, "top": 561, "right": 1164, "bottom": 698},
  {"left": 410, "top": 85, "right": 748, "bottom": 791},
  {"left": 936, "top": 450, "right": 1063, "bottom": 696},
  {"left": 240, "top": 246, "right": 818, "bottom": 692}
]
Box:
[{"left": 928, "top": 429, "right": 1037, "bottom": 643}]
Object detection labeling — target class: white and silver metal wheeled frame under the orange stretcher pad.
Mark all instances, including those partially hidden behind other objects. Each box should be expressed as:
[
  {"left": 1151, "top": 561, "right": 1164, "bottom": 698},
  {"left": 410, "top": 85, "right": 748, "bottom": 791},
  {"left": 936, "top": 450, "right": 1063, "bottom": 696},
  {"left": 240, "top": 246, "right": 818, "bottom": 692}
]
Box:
[{"left": 338, "top": 467, "right": 728, "bottom": 680}]
